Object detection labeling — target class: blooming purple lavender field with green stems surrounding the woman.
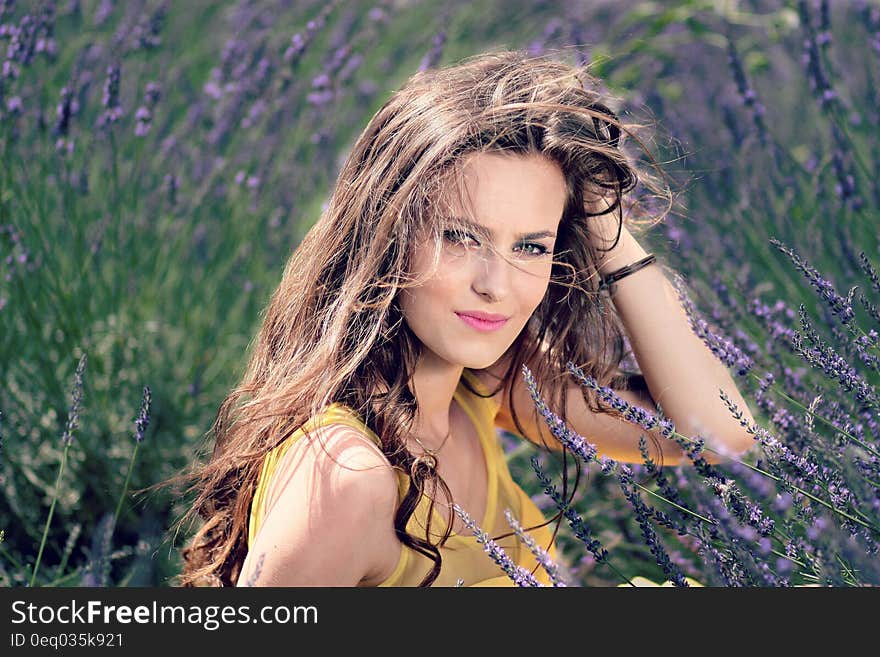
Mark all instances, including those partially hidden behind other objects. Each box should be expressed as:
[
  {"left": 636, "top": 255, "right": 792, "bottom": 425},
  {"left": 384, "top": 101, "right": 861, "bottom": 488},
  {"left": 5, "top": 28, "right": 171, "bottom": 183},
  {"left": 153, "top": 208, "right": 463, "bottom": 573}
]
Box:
[{"left": 0, "top": 0, "right": 880, "bottom": 587}]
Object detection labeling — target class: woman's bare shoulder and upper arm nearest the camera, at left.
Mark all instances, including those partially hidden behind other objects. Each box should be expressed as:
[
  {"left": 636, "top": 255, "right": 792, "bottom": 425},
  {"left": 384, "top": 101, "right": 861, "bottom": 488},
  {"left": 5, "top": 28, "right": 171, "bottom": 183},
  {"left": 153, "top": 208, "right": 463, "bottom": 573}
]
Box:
[{"left": 240, "top": 424, "right": 399, "bottom": 586}]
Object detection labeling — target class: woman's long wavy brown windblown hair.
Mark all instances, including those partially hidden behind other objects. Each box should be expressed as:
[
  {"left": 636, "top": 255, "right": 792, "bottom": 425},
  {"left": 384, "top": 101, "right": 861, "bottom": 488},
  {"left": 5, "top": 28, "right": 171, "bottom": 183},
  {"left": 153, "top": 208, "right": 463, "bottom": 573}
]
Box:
[{"left": 163, "top": 51, "right": 671, "bottom": 586}]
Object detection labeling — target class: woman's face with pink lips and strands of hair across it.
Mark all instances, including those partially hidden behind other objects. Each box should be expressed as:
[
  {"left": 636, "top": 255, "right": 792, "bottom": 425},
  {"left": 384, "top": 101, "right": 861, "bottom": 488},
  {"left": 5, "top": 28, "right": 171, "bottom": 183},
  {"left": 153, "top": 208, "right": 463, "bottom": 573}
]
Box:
[{"left": 401, "top": 153, "right": 566, "bottom": 369}]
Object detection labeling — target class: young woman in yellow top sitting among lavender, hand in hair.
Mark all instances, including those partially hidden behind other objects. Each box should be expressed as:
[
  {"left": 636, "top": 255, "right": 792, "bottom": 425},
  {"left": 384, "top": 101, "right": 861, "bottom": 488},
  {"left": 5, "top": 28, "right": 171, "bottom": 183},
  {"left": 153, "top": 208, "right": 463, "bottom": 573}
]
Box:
[{"left": 167, "top": 52, "right": 753, "bottom": 586}]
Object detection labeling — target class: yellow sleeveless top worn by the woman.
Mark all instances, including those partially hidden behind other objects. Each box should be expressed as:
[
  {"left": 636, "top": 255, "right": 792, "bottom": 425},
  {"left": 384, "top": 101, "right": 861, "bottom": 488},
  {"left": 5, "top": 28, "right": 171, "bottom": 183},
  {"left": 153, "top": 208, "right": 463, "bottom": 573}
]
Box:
[{"left": 248, "top": 370, "right": 557, "bottom": 586}]
